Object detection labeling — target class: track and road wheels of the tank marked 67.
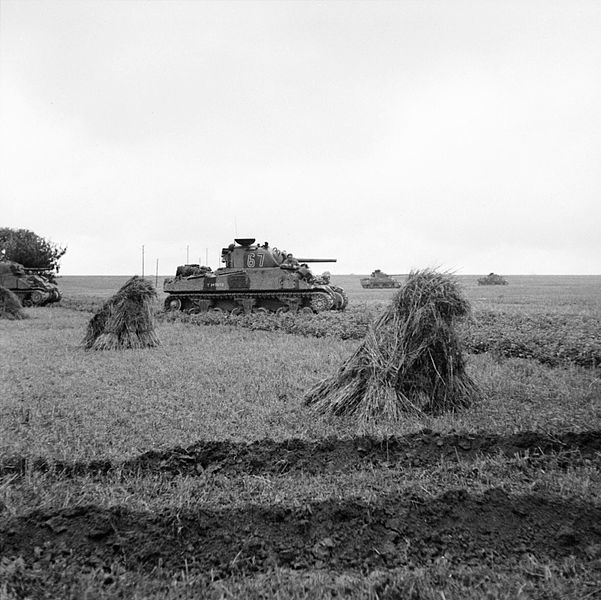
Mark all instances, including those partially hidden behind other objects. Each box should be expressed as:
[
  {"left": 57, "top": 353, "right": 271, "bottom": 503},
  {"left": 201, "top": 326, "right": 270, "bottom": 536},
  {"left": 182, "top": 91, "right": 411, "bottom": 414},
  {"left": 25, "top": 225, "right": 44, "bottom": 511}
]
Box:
[{"left": 165, "top": 288, "right": 346, "bottom": 314}]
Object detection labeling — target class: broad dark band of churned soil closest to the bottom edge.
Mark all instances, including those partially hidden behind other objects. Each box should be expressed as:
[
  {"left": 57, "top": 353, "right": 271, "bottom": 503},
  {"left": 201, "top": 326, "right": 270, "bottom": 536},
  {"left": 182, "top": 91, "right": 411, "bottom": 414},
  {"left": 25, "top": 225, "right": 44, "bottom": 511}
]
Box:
[{"left": 0, "top": 489, "right": 601, "bottom": 576}]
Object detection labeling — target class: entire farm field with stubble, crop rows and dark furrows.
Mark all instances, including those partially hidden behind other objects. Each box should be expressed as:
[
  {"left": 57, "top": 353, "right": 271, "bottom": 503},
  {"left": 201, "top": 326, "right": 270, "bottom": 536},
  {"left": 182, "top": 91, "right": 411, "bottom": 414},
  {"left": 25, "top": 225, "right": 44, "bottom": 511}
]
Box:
[{"left": 0, "top": 275, "right": 601, "bottom": 600}]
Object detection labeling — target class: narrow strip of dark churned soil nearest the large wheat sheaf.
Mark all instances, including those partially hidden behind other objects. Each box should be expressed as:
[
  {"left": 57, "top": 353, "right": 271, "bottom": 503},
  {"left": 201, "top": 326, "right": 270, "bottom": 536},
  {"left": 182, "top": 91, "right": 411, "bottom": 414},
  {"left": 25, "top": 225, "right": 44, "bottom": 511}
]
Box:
[{"left": 0, "top": 430, "right": 601, "bottom": 476}]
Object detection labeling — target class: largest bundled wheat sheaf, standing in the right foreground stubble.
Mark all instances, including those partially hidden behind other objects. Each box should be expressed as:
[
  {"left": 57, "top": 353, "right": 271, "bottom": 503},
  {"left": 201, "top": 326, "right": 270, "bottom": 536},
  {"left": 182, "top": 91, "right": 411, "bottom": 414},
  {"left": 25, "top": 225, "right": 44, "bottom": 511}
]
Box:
[{"left": 305, "top": 269, "right": 477, "bottom": 420}]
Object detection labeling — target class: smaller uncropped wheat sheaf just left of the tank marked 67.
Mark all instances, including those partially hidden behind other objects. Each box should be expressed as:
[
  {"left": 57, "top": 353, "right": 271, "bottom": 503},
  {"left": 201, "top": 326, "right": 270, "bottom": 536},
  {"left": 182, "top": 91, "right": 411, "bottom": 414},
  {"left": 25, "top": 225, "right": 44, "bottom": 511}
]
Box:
[{"left": 83, "top": 276, "right": 159, "bottom": 350}]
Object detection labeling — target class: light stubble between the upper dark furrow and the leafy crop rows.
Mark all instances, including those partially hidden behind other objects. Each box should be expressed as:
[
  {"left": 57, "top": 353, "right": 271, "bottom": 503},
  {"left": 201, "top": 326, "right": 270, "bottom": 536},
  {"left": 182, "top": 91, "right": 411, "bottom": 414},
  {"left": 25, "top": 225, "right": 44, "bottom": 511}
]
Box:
[{"left": 0, "top": 309, "right": 601, "bottom": 460}]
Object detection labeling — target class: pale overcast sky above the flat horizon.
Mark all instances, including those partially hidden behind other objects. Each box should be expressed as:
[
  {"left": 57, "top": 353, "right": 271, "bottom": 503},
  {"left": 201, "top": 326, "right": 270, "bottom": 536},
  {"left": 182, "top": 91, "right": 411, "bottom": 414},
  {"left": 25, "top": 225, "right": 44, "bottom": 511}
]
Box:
[{"left": 0, "top": 0, "right": 601, "bottom": 275}]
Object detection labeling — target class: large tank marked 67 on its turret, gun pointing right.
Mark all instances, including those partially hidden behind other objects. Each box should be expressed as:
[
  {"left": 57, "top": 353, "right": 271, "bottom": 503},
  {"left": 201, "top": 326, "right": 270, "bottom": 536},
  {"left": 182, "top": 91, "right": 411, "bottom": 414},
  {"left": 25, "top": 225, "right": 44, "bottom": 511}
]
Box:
[{"left": 163, "top": 238, "right": 348, "bottom": 314}]
